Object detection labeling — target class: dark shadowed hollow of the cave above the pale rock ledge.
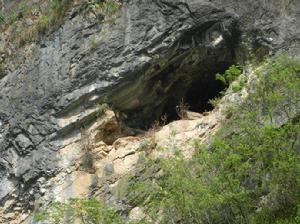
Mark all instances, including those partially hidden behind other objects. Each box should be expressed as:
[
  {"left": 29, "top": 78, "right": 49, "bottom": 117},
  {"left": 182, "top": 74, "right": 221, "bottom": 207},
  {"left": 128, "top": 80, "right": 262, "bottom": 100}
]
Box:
[{"left": 116, "top": 59, "right": 235, "bottom": 130}]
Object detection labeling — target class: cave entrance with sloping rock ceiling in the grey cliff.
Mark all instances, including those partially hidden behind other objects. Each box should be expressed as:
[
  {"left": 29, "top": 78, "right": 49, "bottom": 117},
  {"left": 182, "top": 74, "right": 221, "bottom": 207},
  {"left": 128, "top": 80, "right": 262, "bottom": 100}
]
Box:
[{"left": 113, "top": 43, "right": 236, "bottom": 130}]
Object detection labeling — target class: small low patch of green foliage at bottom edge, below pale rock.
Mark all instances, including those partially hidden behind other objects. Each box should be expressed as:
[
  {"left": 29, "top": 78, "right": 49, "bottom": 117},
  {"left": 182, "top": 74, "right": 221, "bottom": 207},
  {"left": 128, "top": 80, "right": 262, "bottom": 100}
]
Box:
[{"left": 35, "top": 198, "right": 122, "bottom": 224}]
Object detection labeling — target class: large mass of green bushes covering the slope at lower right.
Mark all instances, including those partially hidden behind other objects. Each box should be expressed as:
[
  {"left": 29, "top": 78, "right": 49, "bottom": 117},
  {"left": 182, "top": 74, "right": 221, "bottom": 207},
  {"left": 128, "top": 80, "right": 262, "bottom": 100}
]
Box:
[{"left": 121, "top": 56, "right": 300, "bottom": 224}]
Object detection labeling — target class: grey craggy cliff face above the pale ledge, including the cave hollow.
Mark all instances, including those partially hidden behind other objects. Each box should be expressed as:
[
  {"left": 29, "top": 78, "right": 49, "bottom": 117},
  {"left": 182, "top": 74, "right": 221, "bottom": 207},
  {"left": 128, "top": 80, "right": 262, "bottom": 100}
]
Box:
[{"left": 0, "top": 0, "right": 300, "bottom": 222}]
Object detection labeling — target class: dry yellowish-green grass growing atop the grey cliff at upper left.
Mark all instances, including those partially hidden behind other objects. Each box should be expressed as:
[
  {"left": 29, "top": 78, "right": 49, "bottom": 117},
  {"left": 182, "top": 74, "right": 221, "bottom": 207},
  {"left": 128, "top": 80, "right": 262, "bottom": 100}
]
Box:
[{"left": 0, "top": 0, "right": 121, "bottom": 47}]
